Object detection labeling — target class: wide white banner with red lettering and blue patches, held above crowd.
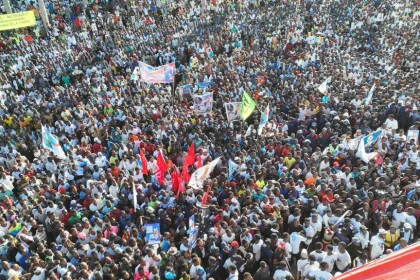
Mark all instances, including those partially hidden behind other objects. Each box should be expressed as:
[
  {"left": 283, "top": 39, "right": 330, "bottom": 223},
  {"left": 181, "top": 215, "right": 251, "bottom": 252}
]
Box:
[{"left": 139, "top": 62, "right": 175, "bottom": 84}]
